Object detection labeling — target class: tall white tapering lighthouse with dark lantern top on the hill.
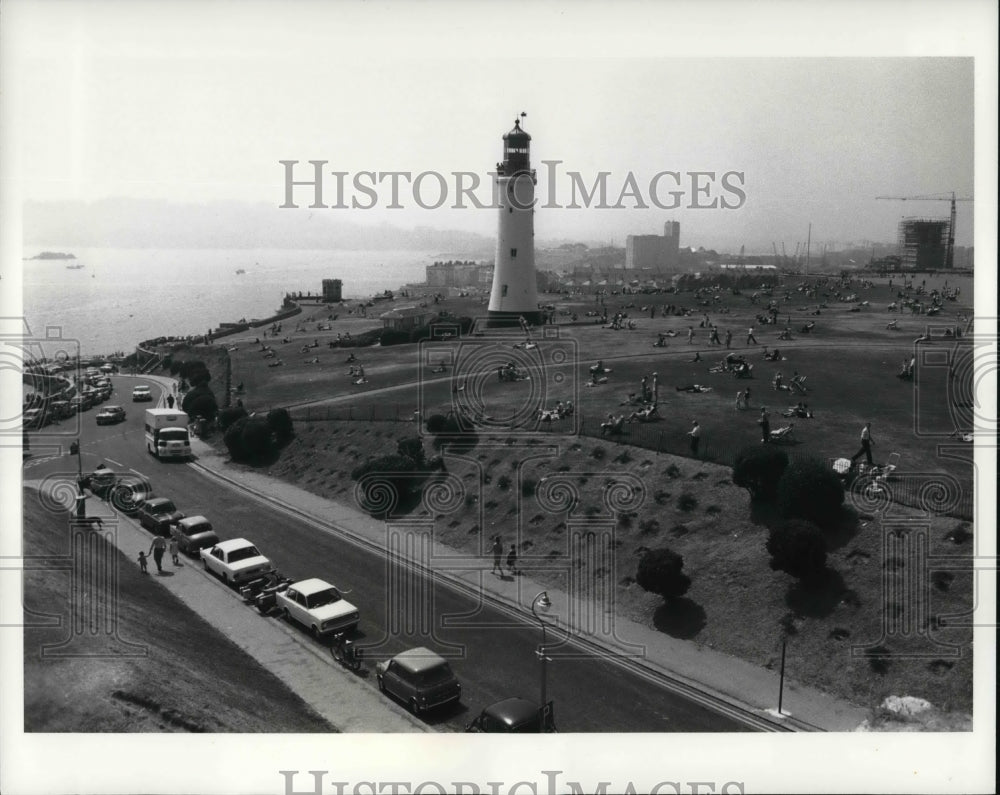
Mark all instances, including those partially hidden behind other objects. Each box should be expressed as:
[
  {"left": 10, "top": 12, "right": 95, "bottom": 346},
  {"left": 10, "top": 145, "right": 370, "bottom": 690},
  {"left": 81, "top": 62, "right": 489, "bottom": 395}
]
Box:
[{"left": 487, "top": 113, "right": 542, "bottom": 327}]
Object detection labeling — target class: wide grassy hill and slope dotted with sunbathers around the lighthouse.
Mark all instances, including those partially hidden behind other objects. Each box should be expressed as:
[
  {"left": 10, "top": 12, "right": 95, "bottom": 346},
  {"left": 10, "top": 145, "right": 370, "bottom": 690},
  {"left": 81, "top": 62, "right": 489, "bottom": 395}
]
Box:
[{"left": 203, "top": 270, "right": 973, "bottom": 711}]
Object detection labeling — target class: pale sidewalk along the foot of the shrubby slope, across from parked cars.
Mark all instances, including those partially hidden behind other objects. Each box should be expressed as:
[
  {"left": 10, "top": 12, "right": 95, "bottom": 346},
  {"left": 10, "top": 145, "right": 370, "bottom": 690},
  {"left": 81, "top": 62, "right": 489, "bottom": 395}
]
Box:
[{"left": 184, "top": 430, "right": 868, "bottom": 731}]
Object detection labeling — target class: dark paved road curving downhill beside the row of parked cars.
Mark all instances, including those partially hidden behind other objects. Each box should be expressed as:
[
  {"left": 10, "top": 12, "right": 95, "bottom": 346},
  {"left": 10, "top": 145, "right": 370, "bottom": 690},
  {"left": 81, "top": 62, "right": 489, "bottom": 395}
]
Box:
[{"left": 26, "top": 378, "right": 746, "bottom": 732}]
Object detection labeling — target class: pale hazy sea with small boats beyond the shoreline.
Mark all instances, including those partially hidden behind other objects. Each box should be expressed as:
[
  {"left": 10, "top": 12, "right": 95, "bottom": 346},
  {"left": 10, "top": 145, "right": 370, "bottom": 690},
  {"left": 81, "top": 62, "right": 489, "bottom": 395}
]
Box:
[{"left": 22, "top": 244, "right": 438, "bottom": 357}]
